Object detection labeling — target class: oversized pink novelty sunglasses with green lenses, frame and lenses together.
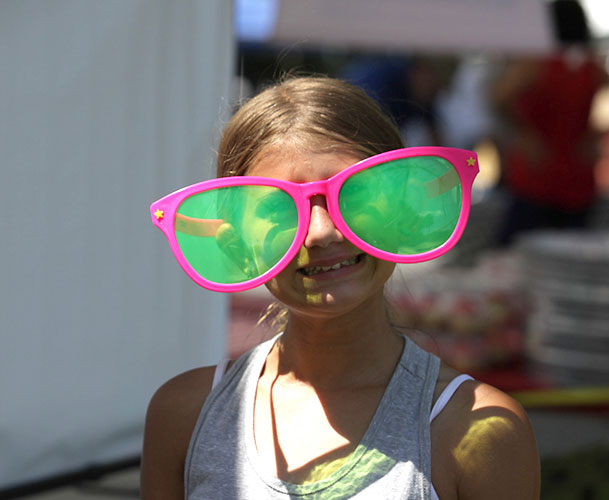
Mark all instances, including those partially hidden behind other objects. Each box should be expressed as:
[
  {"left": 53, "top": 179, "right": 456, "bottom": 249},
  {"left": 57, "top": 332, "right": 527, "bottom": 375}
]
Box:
[{"left": 150, "top": 147, "right": 478, "bottom": 292}]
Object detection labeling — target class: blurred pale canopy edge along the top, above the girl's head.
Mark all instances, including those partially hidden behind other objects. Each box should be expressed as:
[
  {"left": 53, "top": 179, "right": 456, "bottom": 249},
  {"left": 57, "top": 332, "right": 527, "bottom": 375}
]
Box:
[{"left": 270, "top": 0, "right": 551, "bottom": 52}]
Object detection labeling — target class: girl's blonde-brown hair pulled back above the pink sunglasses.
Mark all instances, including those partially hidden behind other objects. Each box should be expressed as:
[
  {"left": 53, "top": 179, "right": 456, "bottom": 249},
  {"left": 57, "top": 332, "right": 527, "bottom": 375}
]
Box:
[{"left": 217, "top": 76, "right": 403, "bottom": 332}]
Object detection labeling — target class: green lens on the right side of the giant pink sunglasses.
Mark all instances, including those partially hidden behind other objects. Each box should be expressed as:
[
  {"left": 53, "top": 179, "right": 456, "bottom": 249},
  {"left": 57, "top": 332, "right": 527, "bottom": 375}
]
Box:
[{"left": 338, "top": 156, "right": 462, "bottom": 255}]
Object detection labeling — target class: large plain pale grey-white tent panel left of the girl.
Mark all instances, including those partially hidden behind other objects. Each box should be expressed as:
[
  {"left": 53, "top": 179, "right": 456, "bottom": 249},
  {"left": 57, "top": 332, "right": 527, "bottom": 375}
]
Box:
[{"left": 0, "top": 0, "right": 234, "bottom": 489}]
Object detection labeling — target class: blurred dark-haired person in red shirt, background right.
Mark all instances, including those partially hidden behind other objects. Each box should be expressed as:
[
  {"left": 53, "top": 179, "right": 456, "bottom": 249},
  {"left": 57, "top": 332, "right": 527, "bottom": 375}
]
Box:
[{"left": 491, "top": 0, "right": 606, "bottom": 244}]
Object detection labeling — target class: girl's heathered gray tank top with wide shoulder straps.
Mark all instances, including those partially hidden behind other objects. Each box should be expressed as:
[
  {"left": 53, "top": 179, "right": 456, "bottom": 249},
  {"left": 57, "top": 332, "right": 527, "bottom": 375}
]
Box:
[{"left": 185, "top": 339, "right": 440, "bottom": 500}]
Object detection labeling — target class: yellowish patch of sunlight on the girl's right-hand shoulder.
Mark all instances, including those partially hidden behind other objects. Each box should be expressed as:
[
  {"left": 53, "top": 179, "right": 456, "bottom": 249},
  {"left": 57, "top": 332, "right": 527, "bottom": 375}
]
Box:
[{"left": 453, "top": 416, "right": 515, "bottom": 464}]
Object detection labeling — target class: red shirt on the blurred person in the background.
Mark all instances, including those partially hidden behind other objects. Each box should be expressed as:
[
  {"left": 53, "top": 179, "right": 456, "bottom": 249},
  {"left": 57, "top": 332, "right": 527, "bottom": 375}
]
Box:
[{"left": 505, "top": 56, "right": 602, "bottom": 210}]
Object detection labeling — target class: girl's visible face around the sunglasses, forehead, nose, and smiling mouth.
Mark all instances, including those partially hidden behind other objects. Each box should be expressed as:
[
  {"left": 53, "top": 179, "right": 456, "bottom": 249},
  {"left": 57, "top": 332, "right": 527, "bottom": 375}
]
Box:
[{"left": 247, "top": 149, "right": 395, "bottom": 315}]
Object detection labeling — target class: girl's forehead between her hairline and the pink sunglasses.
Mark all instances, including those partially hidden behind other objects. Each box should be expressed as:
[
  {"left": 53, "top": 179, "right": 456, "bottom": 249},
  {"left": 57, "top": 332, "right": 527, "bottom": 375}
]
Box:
[{"left": 246, "top": 149, "right": 362, "bottom": 183}]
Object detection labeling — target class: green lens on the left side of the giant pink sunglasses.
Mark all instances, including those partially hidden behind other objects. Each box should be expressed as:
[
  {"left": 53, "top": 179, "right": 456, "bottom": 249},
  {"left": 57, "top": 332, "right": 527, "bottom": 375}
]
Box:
[{"left": 175, "top": 186, "right": 298, "bottom": 284}]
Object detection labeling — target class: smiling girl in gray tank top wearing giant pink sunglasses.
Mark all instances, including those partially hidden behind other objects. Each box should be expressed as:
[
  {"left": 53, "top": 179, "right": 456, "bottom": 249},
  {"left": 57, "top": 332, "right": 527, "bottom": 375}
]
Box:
[{"left": 141, "top": 77, "right": 539, "bottom": 500}]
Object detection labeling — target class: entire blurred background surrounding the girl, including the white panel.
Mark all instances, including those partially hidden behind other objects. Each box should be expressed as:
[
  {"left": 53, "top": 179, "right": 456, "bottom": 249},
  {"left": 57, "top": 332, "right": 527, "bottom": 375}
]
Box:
[{"left": 0, "top": 0, "right": 609, "bottom": 500}]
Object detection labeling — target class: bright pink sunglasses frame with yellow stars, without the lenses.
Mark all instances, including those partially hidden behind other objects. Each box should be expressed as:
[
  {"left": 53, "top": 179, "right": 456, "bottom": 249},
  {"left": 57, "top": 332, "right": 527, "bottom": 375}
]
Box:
[{"left": 150, "top": 146, "right": 479, "bottom": 292}]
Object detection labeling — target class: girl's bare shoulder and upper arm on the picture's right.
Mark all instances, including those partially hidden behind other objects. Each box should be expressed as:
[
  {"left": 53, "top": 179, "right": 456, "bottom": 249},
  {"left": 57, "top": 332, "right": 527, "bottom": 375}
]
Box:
[{"left": 432, "top": 366, "right": 539, "bottom": 500}]
